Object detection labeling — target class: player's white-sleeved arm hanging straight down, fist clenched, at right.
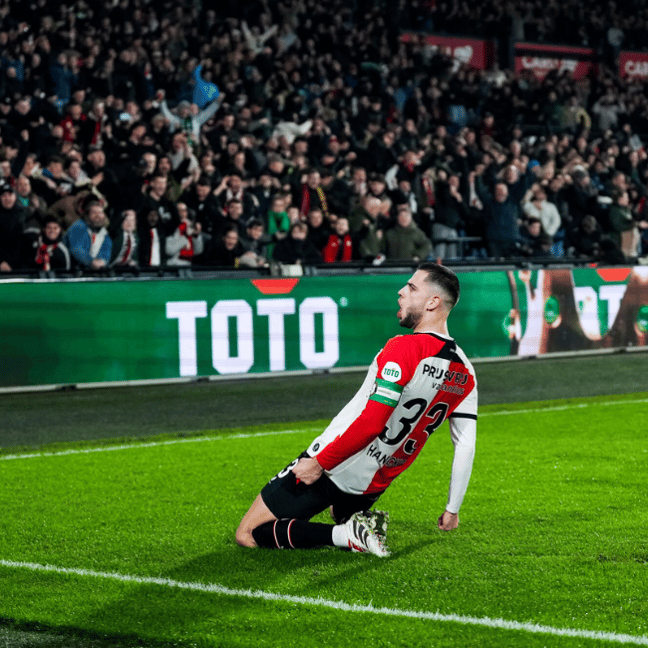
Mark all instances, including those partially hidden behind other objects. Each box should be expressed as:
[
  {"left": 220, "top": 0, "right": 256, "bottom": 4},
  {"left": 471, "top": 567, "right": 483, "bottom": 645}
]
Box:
[{"left": 438, "top": 414, "right": 477, "bottom": 531}]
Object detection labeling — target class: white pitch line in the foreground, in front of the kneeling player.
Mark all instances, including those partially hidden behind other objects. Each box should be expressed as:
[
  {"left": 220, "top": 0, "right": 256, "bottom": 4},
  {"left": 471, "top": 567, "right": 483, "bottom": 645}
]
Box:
[{"left": 0, "top": 560, "right": 648, "bottom": 646}]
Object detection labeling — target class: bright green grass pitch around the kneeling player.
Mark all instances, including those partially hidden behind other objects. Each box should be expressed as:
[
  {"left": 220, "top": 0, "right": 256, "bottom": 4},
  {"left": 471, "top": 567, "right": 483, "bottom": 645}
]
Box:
[{"left": 0, "top": 394, "right": 648, "bottom": 648}]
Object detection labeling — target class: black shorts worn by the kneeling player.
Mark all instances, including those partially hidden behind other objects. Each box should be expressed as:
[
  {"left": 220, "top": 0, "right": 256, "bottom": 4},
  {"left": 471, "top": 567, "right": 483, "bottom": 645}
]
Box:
[{"left": 261, "top": 452, "right": 382, "bottom": 523}]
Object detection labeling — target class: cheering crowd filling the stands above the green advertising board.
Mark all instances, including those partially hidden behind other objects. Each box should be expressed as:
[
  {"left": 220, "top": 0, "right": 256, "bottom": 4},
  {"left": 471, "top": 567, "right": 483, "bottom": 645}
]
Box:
[{"left": 0, "top": 0, "right": 648, "bottom": 272}]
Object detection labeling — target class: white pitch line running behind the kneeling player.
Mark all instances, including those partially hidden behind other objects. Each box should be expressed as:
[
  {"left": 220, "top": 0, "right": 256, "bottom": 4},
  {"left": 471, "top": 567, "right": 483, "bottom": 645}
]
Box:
[{"left": 0, "top": 398, "right": 648, "bottom": 461}]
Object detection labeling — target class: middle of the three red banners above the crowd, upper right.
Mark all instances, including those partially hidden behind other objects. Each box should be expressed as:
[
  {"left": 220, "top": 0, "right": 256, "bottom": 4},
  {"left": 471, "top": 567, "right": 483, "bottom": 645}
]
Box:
[{"left": 515, "top": 43, "right": 598, "bottom": 79}]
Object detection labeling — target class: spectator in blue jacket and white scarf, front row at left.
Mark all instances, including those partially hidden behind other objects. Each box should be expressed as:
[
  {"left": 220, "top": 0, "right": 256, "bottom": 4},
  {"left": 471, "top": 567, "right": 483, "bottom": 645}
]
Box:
[{"left": 64, "top": 200, "right": 112, "bottom": 270}]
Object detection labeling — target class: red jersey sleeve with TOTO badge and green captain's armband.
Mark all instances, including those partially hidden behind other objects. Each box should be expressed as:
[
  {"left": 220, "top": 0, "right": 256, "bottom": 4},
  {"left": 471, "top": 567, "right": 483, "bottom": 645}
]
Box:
[{"left": 317, "top": 336, "right": 416, "bottom": 470}]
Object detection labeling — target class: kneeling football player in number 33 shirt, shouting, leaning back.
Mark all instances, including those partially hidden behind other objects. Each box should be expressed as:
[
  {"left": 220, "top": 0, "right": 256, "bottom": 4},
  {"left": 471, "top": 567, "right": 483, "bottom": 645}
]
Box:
[{"left": 236, "top": 263, "right": 477, "bottom": 556}]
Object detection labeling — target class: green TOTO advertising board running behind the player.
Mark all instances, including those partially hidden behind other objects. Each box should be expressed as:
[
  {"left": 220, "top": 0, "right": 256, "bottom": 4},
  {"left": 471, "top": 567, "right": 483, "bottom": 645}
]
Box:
[{"left": 0, "top": 267, "right": 648, "bottom": 387}]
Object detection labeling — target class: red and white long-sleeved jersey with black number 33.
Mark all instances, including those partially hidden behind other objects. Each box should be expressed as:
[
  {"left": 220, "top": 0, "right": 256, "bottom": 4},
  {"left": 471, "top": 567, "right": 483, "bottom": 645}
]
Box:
[{"left": 308, "top": 333, "right": 477, "bottom": 513}]
